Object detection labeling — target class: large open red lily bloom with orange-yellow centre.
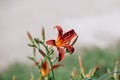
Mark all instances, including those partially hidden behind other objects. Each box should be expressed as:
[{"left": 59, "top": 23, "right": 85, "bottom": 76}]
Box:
[{"left": 46, "top": 26, "right": 77, "bottom": 61}]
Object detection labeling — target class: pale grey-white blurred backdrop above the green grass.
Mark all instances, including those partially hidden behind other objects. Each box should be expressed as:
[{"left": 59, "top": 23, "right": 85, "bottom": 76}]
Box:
[{"left": 0, "top": 0, "right": 120, "bottom": 79}]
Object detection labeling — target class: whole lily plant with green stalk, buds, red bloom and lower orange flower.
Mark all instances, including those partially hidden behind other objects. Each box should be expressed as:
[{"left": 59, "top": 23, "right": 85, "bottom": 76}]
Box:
[{"left": 27, "top": 26, "right": 78, "bottom": 80}]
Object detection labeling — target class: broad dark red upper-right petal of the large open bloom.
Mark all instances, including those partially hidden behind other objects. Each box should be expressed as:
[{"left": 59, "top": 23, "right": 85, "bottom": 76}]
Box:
[{"left": 63, "top": 29, "right": 77, "bottom": 42}]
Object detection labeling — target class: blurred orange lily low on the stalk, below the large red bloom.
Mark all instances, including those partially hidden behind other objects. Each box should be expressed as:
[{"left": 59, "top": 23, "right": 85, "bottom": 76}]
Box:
[{"left": 40, "top": 61, "right": 63, "bottom": 77}]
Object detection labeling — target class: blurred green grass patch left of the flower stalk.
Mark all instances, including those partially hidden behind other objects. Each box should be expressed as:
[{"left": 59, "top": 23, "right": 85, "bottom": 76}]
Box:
[{"left": 0, "top": 62, "right": 39, "bottom": 80}]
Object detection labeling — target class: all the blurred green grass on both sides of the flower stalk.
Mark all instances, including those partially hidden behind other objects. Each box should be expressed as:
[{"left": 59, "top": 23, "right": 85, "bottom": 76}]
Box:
[{"left": 0, "top": 43, "right": 120, "bottom": 80}]
